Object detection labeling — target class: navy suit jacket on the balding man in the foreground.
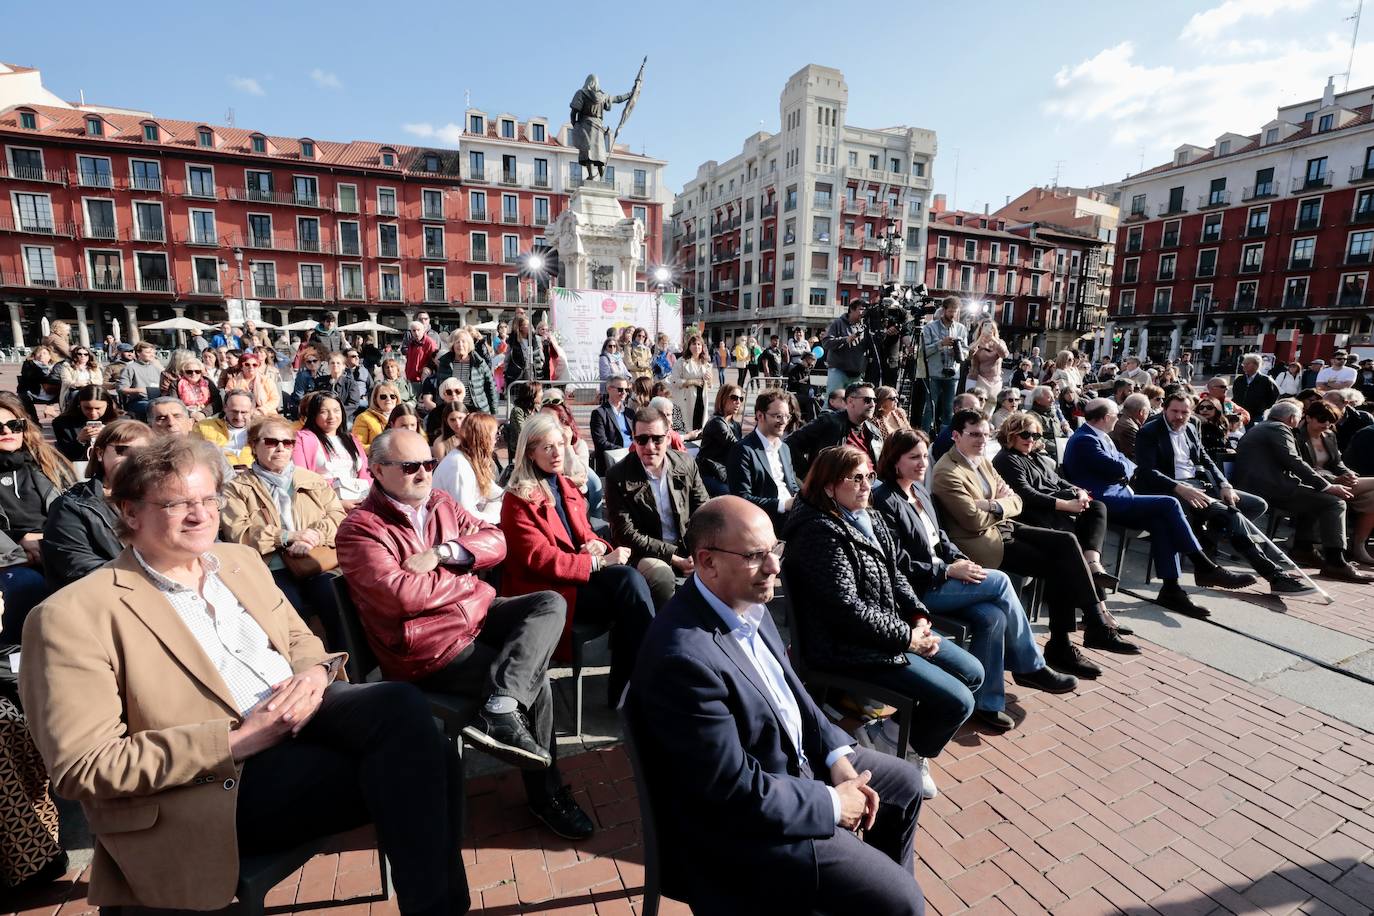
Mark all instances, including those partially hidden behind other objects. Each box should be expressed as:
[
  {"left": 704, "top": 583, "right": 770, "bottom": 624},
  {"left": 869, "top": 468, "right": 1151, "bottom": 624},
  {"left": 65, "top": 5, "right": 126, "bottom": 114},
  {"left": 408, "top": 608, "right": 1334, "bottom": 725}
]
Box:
[{"left": 625, "top": 578, "right": 852, "bottom": 913}]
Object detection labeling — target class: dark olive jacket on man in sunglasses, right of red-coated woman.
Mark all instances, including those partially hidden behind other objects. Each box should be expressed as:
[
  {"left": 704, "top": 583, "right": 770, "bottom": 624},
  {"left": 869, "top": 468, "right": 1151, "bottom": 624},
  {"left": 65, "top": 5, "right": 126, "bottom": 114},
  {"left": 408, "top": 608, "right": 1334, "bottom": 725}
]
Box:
[{"left": 606, "top": 450, "right": 710, "bottom": 563}]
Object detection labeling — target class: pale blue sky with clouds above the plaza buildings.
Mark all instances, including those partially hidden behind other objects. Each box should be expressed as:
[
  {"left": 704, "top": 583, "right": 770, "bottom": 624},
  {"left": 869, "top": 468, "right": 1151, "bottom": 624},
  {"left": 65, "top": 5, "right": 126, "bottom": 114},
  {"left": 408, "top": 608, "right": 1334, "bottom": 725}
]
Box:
[{"left": 0, "top": 0, "right": 1374, "bottom": 210}]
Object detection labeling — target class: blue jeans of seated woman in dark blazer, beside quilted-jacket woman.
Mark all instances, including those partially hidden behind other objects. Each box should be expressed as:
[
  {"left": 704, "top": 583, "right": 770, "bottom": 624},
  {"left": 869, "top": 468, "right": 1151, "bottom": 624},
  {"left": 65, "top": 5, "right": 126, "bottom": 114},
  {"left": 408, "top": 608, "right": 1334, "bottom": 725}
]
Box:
[{"left": 921, "top": 570, "right": 1044, "bottom": 713}]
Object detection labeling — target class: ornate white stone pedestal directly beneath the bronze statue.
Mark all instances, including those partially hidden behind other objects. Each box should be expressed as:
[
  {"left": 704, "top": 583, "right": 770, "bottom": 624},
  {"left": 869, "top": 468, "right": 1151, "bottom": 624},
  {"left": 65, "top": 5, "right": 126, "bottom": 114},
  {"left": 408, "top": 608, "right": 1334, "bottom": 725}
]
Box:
[{"left": 548, "top": 183, "right": 644, "bottom": 291}]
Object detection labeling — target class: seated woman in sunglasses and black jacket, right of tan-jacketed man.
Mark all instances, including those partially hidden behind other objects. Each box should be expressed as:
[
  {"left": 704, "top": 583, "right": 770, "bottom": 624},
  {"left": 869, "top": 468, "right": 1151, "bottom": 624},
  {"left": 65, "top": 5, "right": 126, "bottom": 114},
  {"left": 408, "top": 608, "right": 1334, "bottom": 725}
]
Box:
[{"left": 992, "top": 411, "right": 1116, "bottom": 589}]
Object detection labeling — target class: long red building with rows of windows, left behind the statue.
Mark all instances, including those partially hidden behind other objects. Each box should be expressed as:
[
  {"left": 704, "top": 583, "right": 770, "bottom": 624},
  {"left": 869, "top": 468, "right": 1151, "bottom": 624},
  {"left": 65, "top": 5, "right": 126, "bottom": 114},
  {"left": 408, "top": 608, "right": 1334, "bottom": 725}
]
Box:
[{"left": 0, "top": 61, "right": 664, "bottom": 343}]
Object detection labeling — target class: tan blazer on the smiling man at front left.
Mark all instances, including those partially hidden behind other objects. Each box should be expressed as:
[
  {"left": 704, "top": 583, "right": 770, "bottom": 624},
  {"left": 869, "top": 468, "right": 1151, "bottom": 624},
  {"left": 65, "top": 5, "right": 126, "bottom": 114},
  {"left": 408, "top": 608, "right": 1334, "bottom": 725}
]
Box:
[{"left": 19, "top": 544, "right": 342, "bottom": 909}]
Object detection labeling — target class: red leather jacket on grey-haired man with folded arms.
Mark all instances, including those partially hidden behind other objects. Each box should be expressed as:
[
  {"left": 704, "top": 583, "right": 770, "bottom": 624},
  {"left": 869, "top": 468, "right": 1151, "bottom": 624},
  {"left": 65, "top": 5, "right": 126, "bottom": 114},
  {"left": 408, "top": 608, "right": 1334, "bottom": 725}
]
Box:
[{"left": 334, "top": 486, "right": 506, "bottom": 681}]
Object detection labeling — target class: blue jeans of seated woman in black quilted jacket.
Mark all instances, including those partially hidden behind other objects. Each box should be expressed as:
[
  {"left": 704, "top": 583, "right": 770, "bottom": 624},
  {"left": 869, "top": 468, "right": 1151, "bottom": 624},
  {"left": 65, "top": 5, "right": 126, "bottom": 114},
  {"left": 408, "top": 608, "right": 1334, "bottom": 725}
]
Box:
[{"left": 853, "top": 640, "right": 982, "bottom": 757}]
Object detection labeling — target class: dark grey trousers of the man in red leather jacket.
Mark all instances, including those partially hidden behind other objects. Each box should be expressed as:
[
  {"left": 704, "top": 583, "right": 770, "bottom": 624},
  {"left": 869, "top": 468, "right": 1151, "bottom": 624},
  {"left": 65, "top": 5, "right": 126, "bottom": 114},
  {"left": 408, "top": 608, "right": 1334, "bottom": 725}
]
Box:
[{"left": 416, "top": 592, "right": 567, "bottom": 806}]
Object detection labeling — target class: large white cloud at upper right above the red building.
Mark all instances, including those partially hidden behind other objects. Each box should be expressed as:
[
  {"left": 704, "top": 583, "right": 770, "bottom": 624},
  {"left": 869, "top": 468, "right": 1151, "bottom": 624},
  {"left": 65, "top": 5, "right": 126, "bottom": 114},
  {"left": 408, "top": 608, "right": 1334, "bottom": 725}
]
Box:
[{"left": 1044, "top": 34, "right": 1374, "bottom": 152}]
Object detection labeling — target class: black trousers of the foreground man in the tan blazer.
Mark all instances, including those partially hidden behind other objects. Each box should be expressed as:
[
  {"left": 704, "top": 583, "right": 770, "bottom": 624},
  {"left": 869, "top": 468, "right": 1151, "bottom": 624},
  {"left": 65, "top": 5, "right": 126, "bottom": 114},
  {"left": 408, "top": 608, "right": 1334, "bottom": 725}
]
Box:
[{"left": 236, "top": 683, "right": 469, "bottom": 913}]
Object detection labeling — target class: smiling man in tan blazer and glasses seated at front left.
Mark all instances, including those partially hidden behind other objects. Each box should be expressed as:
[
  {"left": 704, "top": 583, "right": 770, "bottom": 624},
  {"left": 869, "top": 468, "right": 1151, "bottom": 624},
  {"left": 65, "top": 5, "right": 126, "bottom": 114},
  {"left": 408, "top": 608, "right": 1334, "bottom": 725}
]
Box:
[{"left": 19, "top": 439, "right": 467, "bottom": 913}]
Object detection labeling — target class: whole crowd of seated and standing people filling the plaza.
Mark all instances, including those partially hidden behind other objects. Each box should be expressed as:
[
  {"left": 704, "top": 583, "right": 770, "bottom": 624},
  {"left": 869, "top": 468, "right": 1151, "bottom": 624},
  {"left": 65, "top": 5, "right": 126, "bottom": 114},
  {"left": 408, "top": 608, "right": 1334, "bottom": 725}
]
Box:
[{"left": 0, "top": 301, "right": 1374, "bottom": 913}]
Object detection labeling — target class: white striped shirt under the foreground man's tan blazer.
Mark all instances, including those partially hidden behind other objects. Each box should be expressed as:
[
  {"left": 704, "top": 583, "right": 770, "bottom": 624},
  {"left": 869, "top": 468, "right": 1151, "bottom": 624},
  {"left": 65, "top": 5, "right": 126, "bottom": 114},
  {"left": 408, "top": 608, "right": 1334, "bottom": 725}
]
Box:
[{"left": 133, "top": 548, "right": 294, "bottom": 715}]
